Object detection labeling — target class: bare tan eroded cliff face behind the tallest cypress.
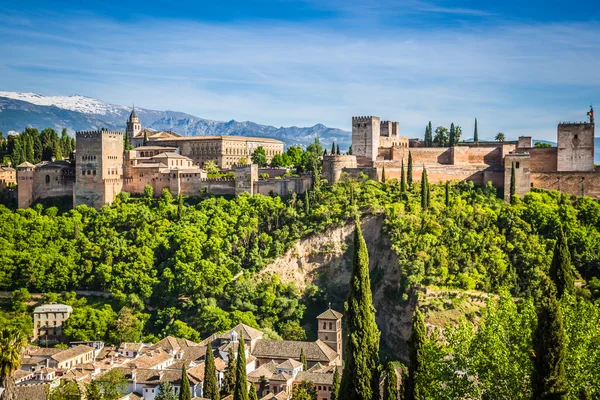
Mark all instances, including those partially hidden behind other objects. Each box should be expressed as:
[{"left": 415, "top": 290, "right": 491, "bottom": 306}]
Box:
[{"left": 262, "top": 216, "right": 417, "bottom": 360}]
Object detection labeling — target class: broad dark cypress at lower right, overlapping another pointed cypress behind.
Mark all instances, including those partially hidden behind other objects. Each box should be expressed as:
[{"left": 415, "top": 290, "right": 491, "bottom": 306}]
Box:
[{"left": 531, "top": 277, "right": 567, "bottom": 400}]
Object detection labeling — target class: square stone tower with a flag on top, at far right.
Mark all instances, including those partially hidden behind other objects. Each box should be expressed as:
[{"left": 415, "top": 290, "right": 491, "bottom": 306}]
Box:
[{"left": 556, "top": 122, "right": 594, "bottom": 171}]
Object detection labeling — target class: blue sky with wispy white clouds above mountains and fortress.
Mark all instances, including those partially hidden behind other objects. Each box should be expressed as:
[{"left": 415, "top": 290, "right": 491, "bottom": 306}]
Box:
[{"left": 0, "top": 0, "right": 600, "bottom": 140}]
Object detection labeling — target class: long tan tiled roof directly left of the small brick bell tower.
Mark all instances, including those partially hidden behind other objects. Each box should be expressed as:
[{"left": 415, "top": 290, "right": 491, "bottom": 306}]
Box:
[{"left": 252, "top": 340, "right": 338, "bottom": 363}]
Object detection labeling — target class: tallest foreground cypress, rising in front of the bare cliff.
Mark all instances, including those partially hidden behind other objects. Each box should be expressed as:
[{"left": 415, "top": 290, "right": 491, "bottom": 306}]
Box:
[{"left": 339, "top": 219, "right": 380, "bottom": 400}]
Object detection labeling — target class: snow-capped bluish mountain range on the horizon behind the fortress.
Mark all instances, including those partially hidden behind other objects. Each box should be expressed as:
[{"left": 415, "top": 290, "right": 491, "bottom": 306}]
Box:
[{"left": 0, "top": 91, "right": 351, "bottom": 149}]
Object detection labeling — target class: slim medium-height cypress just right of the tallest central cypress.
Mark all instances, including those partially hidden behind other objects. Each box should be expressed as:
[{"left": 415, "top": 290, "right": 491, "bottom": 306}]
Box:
[{"left": 404, "top": 309, "right": 427, "bottom": 400}]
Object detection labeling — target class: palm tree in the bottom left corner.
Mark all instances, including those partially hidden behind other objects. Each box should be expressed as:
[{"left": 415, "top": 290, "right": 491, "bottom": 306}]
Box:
[{"left": 0, "top": 326, "right": 27, "bottom": 400}]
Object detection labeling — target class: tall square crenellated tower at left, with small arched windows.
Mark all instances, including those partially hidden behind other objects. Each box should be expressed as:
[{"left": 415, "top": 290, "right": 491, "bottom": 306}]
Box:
[{"left": 73, "top": 130, "right": 124, "bottom": 208}]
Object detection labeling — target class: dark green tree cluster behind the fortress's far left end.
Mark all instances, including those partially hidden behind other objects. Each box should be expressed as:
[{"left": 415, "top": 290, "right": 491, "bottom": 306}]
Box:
[{"left": 0, "top": 128, "right": 75, "bottom": 167}]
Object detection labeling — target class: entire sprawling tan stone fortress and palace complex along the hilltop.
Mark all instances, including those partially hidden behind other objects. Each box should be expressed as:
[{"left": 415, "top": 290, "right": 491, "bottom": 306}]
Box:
[{"left": 0, "top": 109, "right": 600, "bottom": 208}]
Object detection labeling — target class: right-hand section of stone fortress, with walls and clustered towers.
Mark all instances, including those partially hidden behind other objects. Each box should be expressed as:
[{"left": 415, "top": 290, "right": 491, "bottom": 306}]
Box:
[{"left": 323, "top": 109, "right": 600, "bottom": 199}]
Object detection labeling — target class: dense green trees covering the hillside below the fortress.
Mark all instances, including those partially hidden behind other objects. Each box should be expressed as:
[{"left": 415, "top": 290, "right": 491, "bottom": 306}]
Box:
[{"left": 0, "top": 179, "right": 600, "bottom": 398}]
